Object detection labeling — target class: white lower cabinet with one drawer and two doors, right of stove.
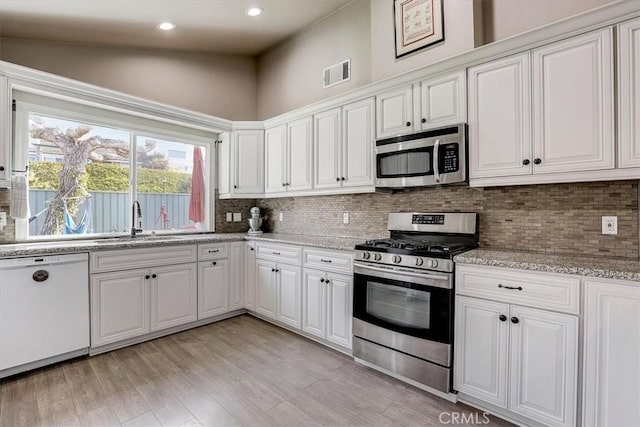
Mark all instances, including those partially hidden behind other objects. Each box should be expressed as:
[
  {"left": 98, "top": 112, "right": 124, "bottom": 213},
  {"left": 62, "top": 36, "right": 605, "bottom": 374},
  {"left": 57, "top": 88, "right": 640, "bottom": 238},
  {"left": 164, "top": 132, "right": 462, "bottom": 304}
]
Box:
[{"left": 453, "top": 265, "right": 578, "bottom": 427}]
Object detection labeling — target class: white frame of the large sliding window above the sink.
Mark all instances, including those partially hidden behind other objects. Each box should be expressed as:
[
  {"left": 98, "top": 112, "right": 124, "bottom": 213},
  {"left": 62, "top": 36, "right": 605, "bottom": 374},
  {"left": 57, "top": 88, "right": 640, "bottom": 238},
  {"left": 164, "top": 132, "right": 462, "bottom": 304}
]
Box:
[{"left": 12, "top": 98, "right": 218, "bottom": 241}]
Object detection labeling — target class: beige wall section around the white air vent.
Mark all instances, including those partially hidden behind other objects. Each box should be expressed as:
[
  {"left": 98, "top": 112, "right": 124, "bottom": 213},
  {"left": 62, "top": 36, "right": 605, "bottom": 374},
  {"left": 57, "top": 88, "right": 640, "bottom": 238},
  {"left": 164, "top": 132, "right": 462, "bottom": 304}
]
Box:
[{"left": 258, "top": 0, "right": 371, "bottom": 119}]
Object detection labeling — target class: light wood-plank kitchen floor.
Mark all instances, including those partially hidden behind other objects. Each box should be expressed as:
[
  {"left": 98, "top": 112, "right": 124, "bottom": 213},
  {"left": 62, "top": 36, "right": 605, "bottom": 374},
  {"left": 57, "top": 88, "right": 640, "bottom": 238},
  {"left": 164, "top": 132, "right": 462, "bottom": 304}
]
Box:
[{"left": 0, "top": 315, "right": 509, "bottom": 427}]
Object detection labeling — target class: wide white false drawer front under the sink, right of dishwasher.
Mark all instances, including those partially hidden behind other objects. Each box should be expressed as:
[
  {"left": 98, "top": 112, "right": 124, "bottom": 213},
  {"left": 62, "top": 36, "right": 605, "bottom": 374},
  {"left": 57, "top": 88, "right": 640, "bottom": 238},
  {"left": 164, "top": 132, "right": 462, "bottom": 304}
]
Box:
[{"left": 91, "top": 245, "right": 196, "bottom": 273}]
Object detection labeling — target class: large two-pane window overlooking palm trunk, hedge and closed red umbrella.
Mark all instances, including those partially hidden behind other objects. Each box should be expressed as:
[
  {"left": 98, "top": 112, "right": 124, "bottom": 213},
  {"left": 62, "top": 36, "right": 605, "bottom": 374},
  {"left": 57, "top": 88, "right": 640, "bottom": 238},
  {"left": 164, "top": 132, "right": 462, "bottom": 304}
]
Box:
[{"left": 14, "top": 94, "right": 216, "bottom": 238}]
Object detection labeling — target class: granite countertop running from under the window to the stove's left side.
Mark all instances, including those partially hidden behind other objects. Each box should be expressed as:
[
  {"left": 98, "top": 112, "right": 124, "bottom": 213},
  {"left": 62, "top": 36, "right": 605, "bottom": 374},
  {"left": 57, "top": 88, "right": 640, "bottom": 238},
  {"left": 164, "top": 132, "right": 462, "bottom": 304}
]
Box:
[{"left": 0, "top": 233, "right": 364, "bottom": 258}]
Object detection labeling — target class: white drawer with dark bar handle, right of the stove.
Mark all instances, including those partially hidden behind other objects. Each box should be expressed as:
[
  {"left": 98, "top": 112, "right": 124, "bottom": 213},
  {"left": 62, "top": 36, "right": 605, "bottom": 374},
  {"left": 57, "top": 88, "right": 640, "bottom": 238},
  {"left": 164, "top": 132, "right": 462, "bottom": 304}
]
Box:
[{"left": 456, "top": 265, "right": 580, "bottom": 314}]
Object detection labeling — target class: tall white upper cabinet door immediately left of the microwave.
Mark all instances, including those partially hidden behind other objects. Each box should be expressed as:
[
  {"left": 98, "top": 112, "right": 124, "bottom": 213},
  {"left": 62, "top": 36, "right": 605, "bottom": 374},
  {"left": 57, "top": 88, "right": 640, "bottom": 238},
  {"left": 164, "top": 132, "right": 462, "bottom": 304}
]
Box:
[{"left": 340, "top": 98, "right": 375, "bottom": 187}]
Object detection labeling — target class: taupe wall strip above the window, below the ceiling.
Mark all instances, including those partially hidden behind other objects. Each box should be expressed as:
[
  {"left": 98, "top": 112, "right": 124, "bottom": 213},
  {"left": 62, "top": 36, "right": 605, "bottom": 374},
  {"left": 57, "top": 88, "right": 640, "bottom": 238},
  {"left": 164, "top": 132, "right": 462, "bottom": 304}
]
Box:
[{"left": 0, "top": 38, "right": 257, "bottom": 120}]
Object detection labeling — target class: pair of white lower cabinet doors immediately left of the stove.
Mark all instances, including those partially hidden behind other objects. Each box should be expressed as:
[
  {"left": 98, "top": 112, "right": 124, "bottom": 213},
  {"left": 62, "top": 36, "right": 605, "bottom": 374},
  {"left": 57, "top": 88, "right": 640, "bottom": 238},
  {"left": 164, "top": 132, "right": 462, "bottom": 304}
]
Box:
[{"left": 302, "top": 268, "right": 353, "bottom": 348}]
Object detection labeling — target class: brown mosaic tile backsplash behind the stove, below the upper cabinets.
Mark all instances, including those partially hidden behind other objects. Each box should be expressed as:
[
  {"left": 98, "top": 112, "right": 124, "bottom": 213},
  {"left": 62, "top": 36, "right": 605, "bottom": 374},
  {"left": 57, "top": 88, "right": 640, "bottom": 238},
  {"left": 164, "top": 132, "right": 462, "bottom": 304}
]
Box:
[{"left": 257, "top": 180, "right": 638, "bottom": 258}]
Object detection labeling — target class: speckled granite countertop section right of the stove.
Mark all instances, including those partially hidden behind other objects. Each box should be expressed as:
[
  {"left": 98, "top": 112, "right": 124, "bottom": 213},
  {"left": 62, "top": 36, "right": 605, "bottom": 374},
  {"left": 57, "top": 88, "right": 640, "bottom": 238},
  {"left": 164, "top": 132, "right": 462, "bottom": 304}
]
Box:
[{"left": 454, "top": 249, "right": 640, "bottom": 280}]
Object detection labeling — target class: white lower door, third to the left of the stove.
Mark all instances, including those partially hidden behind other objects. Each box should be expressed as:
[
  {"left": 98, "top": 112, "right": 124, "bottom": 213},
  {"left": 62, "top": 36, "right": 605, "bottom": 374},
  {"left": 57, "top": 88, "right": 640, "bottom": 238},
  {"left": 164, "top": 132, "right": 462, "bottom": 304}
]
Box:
[{"left": 276, "top": 264, "right": 302, "bottom": 329}]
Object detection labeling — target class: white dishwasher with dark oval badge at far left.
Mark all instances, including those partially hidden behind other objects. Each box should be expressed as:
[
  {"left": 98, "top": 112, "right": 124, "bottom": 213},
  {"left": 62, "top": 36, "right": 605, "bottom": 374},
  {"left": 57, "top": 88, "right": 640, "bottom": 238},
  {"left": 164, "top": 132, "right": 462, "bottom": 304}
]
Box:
[{"left": 0, "top": 254, "right": 89, "bottom": 378}]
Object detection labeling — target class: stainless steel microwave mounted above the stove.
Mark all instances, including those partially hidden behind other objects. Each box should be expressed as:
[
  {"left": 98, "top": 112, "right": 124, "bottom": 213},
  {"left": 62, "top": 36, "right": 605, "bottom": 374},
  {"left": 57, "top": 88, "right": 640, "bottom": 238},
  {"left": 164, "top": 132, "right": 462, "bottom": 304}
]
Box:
[{"left": 376, "top": 124, "right": 467, "bottom": 188}]
